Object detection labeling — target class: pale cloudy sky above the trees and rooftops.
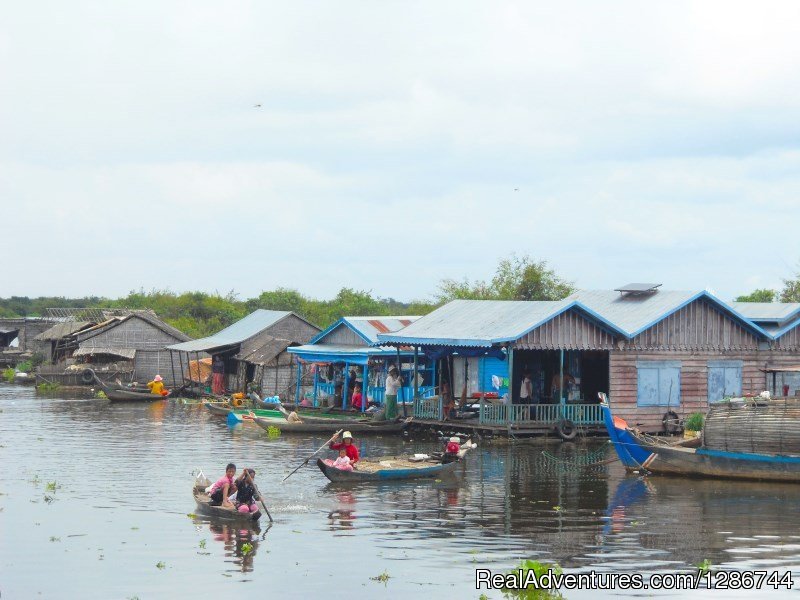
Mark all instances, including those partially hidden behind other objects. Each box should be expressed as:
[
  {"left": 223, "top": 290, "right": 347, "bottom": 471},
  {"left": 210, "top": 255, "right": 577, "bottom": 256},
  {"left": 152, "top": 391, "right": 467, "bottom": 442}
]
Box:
[{"left": 0, "top": 0, "right": 800, "bottom": 300}]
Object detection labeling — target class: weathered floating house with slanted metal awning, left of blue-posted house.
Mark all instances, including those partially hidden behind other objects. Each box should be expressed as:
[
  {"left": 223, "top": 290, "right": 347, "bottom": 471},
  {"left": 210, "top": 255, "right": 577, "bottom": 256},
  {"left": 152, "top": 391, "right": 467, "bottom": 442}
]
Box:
[{"left": 168, "top": 309, "right": 320, "bottom": 398}]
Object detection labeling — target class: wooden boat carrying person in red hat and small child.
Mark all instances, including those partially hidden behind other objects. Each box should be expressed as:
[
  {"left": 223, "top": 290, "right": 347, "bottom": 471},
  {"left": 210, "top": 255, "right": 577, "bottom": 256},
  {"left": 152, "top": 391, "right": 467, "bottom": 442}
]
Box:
[{"left": 317, "top": 442, "right": 477, "bottom": 483}]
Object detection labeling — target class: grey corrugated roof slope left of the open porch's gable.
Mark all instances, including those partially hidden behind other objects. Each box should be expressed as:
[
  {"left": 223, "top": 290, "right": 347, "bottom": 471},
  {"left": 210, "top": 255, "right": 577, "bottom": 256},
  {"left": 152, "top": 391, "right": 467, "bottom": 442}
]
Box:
[{"left": 378, "top": 300, "right": 574, "bottom": 346}]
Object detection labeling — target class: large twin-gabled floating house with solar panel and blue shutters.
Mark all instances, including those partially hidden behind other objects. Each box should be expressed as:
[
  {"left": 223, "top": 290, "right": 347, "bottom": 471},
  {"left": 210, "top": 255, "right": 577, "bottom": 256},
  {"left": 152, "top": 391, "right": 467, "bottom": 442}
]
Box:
[{"left": 377, "top": 284, "right": 800, "bottom": 432}]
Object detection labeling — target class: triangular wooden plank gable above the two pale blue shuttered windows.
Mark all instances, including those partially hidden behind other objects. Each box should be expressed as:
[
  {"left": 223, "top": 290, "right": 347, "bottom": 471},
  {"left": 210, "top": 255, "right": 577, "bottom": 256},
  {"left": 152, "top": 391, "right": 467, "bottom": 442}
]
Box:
[{"left": 626, "top": 299, "right": 759, "bottom": 351}]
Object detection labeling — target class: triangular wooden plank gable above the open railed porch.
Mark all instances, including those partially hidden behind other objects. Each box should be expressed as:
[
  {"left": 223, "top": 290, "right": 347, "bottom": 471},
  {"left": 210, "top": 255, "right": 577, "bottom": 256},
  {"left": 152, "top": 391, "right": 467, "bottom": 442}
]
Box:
[{"left": 514, "top": 310, "right": 616, "bottom": 350}]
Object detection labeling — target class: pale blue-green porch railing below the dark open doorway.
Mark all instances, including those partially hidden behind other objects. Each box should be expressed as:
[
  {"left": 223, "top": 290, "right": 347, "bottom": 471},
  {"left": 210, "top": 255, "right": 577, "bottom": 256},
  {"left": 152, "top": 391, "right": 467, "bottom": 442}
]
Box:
[{"left": 478, "top": 400, "right": 603, "bottom": 426}]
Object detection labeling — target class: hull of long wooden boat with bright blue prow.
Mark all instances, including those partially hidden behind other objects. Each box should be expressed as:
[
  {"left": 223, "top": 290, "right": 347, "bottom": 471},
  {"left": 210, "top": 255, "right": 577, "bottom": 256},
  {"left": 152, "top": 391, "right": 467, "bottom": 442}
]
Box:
[{"left": 601, "top": 402, "right": 800, "bottom": 483}]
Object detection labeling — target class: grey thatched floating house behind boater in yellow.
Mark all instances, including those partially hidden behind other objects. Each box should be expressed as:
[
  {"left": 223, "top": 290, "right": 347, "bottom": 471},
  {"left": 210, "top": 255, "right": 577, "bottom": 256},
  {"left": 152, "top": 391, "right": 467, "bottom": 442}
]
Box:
[{"left": 72, "top": 311, "right": 192, "bottom": 386}]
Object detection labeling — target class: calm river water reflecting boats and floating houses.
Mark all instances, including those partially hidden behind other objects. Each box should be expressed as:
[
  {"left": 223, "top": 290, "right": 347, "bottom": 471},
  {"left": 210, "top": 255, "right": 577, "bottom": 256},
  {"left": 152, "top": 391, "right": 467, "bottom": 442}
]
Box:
[{"left": 0, "top": 384, "right": 800, "bottom": 600}]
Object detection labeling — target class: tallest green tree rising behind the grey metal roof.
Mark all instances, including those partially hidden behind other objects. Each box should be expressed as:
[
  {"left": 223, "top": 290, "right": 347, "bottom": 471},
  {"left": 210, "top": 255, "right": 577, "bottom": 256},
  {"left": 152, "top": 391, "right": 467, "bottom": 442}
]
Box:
[{"left": 436, "top": 254, "right": 575, "bottom": 302}]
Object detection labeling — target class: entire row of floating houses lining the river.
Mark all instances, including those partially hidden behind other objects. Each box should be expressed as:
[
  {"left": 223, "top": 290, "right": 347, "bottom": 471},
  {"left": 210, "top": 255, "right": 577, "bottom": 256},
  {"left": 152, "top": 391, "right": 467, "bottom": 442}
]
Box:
[{"left": 0, "top": 284, "right": 800, "bottom": 440}]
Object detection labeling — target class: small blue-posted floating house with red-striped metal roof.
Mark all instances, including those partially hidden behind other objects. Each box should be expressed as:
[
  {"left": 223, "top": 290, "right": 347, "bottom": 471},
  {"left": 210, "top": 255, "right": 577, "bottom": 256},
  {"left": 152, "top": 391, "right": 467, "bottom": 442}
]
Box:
[{"left": 289, "top": 316, "right": 437, "bottom": 409}]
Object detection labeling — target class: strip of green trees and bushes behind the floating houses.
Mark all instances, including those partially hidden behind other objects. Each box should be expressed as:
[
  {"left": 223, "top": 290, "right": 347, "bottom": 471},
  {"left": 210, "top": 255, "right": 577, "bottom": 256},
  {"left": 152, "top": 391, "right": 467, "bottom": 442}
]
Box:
[{"left": 0, "top": 255, "right": 573, "bottom": 337}]
